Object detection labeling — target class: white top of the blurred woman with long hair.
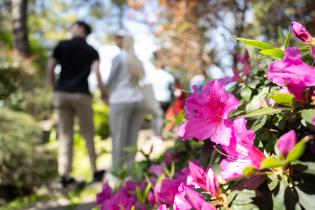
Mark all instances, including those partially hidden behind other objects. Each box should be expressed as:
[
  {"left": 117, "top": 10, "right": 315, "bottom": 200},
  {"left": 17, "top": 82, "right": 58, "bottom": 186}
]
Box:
[{"left": 106, "top": 50, "right": 143, "bottom": 105}]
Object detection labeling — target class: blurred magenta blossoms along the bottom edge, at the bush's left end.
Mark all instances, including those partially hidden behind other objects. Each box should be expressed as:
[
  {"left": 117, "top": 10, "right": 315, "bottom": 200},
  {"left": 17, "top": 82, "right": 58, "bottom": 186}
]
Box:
[{"left": 96, "top": 167, "right": 189, "bottom": 210}]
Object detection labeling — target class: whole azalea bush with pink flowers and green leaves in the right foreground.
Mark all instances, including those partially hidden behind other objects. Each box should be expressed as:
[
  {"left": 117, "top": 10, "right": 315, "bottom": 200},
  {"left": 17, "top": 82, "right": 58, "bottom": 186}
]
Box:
[{"left": 97, "top": 22, "right": 315, "bottom": 210}]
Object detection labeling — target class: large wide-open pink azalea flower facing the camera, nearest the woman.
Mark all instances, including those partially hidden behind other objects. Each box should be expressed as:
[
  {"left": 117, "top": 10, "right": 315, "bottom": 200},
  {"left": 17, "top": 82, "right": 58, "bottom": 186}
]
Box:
[{"left": 179, "top": 80, "right": 240, "bottom": 146}]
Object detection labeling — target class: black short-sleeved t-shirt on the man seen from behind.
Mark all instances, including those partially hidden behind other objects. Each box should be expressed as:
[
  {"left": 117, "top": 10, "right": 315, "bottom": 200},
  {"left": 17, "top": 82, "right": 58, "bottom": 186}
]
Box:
[{"left": 52, "top": 37, "right": 99, "bottom": 94}]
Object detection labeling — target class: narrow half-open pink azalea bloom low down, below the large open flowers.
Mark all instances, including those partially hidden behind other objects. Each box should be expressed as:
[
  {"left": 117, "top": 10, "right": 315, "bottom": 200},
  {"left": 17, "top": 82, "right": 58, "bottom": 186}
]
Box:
[{"left": 189, "top": 162, "right": 220, "bottom": 197}]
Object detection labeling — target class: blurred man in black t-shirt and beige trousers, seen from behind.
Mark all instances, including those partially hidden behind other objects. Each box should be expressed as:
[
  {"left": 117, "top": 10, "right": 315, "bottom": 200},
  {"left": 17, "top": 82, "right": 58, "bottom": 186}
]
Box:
[{"left": 47, "top": 21, "right": 106, "bottom": 187}]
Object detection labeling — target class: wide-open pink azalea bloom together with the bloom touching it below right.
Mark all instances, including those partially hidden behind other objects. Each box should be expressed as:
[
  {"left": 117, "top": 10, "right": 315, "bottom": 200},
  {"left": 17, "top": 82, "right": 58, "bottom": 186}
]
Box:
[{"left": 179, "top": 80, "right": 265, "bottom": 180}]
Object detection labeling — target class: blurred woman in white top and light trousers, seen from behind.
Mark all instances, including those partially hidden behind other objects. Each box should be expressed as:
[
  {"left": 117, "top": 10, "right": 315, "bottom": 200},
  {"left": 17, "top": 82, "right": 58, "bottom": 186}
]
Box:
[{"left": 107, "top": 32, "right": 144, "bottom": 169}]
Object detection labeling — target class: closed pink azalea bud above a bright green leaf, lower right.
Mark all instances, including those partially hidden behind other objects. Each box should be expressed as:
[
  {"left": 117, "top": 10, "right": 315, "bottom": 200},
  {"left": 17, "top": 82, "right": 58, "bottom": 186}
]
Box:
[{"left": 276, "top": 130, "right": 296, "bottom": 157}]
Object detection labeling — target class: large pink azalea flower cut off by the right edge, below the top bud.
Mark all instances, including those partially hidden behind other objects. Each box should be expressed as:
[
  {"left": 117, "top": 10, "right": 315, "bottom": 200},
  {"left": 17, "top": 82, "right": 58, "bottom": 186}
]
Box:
[{"left": 267, "top": 47, "right": 315, "bottom": 101}]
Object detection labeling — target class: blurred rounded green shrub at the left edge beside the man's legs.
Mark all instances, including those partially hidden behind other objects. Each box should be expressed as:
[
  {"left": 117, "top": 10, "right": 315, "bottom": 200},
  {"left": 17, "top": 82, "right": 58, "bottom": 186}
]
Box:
[{"left": 0, "top": 109, "right": 57, "bottom": 201}]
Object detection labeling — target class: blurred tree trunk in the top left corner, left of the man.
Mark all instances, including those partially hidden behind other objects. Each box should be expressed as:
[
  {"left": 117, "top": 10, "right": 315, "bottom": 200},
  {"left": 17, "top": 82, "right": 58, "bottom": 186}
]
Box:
[{"left": 11, "top": 0, "right": 30, "bottom": 57}]
